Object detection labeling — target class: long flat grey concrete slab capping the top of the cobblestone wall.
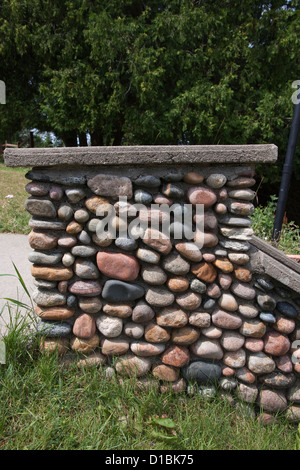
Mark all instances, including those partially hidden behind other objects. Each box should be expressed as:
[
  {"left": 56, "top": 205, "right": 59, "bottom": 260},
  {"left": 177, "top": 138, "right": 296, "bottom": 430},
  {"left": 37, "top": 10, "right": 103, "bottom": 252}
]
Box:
[{"left": 4, "top": 144, "right": 278, "bottom": 167}]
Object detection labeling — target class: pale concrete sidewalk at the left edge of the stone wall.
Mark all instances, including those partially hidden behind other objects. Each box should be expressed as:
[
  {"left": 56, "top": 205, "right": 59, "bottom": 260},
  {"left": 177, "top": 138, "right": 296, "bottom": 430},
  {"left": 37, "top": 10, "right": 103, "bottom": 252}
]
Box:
[{"left": 0, "top": 233, "right": 34, "bottom": 336}]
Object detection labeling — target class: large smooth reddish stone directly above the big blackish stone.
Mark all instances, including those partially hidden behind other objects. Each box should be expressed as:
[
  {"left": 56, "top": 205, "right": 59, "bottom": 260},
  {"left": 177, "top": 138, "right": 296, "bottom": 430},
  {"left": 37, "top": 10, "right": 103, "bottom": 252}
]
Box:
[{"left": 97, "top": 251, "right": 140, "bottom": 281}]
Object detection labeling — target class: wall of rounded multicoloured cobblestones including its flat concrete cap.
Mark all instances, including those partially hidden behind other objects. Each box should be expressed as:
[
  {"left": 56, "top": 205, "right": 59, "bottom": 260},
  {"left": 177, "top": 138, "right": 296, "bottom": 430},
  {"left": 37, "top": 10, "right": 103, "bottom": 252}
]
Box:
[{"left": 5, "top": 146, "right": 300, "bottom": 420}]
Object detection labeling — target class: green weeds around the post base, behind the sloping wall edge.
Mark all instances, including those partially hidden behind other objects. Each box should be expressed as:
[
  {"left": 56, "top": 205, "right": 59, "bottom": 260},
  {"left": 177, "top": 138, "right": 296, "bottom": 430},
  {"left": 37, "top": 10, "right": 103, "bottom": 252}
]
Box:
[{"left": 252, "top": 195, "right": 300, "bottom": 255}]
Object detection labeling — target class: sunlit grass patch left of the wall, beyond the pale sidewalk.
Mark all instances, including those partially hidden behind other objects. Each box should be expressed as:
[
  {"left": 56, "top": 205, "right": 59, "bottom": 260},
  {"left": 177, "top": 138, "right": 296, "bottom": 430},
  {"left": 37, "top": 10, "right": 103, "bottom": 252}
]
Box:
[{"left": 0, "top": 161, "right": 30, "bottom": 234}]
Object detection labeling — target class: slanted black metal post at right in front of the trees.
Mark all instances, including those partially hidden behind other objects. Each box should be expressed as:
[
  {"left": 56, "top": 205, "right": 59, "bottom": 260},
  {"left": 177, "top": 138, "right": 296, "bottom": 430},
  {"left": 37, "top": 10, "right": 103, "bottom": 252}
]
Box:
[{"left": 272, "top": 99, "right": 300, "bottom": 242}]
